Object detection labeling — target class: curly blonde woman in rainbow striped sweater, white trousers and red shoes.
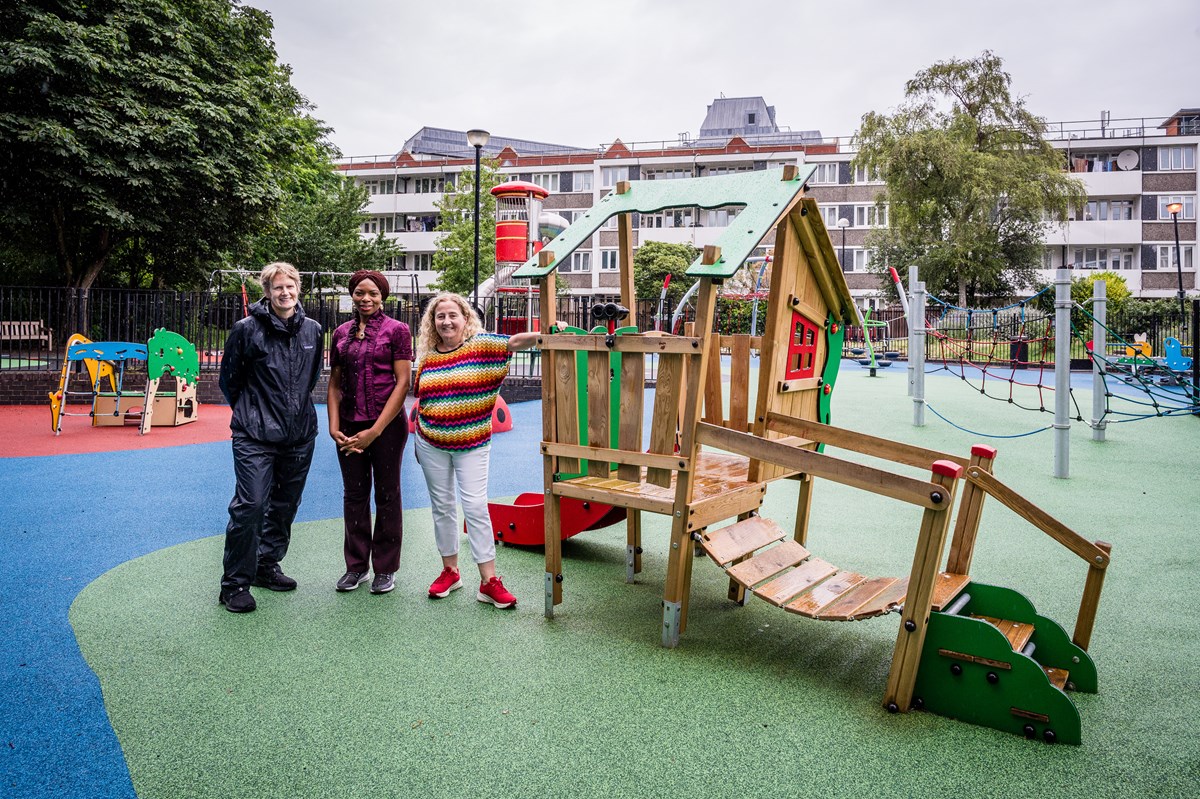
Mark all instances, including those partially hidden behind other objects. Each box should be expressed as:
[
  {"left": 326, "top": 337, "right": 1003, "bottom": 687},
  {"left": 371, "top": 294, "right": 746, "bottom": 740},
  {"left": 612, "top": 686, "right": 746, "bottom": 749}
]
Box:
[{"left": 416, "top": 292, "right": 556, "bottom": 608}]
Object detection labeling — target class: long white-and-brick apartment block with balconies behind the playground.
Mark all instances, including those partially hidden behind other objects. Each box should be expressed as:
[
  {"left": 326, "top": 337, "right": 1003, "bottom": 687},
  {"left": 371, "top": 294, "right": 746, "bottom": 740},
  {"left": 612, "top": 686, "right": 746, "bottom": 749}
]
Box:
[{"left": 340, "top": 97, "right": 1200, "bottom": 307}]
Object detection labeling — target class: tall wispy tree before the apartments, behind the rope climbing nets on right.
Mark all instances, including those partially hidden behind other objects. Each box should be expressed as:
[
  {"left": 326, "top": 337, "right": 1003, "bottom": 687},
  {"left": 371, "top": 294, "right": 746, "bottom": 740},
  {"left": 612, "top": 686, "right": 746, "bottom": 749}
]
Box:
[{"left": 854, "top": 52, "right": 1086, "bottom": 305}]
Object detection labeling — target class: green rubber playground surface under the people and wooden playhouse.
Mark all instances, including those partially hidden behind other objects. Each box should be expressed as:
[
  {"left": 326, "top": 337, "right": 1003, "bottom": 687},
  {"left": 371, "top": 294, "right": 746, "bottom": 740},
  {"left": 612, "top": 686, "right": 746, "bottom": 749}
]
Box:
[{"left": 71, "top": 366, "right": 1200, "bottom": 799}]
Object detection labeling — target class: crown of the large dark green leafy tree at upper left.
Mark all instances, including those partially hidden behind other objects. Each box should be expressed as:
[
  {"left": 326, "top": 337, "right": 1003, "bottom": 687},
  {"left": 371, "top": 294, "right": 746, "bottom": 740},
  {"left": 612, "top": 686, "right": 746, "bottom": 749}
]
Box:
[{"left": 0, "top": 0, "right": 311, "bottom": 288}]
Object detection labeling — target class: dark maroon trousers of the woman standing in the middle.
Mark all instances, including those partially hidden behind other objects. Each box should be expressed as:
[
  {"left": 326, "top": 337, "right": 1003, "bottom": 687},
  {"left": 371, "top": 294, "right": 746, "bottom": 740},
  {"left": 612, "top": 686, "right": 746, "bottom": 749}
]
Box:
[{"left": 337, "top": 414, "right": 408, "bottom": 575}]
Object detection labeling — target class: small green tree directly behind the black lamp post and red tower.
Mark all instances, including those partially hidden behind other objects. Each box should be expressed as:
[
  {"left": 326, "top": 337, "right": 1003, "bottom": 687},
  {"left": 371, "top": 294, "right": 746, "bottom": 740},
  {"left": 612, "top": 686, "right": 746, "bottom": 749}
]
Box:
[{"left": 433, "top": 158, "right": 501, "bottom": 296}]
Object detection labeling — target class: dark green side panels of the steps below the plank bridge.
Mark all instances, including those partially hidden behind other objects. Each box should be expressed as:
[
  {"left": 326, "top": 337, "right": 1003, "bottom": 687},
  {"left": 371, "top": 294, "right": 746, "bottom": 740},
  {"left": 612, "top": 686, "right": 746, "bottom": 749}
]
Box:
[{"left": 913, "top": 583, "right": 1096, "bottom": 744}]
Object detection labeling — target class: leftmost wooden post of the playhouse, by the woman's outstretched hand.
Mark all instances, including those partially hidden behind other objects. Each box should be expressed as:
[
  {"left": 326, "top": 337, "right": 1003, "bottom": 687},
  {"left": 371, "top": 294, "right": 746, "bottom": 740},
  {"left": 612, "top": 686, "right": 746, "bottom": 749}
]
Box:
[{"left": 538, "top": 275, "right": 564, "bottom": 618}]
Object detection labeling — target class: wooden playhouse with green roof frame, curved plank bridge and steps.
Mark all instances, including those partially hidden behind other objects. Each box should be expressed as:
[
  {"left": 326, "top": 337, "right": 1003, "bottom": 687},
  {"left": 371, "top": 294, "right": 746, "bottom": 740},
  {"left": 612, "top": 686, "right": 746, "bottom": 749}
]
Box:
[{"left": 514, "top": 167, "right": 1110, "bottom": 743}]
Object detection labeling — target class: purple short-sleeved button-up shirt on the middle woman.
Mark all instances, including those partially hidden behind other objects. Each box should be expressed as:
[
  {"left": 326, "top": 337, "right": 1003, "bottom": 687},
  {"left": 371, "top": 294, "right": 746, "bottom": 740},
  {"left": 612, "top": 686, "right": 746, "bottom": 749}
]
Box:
[{"left": 330, "top": 311, "right": 413, "bottom": 421}]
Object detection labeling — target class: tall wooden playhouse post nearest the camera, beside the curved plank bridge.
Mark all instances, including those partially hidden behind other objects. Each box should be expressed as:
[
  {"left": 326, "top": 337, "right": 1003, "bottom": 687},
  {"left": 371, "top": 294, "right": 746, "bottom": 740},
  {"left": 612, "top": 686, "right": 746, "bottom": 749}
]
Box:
[{"left": 662, "top": 277, "right": 716, "bottom": 647}]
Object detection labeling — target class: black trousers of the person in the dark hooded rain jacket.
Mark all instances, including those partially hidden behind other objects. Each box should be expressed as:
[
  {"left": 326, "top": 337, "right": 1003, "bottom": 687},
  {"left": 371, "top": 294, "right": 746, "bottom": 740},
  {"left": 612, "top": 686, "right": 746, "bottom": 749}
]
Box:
[{"left": 221, "top": 437, "right": 317, "bottom": 588}]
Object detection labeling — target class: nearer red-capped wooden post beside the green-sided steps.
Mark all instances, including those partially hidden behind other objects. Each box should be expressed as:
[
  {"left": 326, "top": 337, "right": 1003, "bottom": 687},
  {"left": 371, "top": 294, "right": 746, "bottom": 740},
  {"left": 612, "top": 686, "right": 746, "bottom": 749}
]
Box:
[{"left": 883, "top": 461, "right": 962, "bottom": 713}]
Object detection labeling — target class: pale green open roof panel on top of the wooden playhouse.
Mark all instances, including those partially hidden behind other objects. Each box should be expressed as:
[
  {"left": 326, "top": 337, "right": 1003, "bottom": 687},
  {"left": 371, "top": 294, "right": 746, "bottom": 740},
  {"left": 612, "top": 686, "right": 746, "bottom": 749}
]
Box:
[{"left": 512, "top": 166, "right": 816, "bottom": 280}]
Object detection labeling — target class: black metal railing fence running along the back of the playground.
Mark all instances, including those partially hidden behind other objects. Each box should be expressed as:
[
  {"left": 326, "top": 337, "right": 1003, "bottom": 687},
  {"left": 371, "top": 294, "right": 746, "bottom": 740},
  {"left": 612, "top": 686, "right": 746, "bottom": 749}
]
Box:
[{"left": 0, "top": 287, "right": 1188, "bottom": 377}]
